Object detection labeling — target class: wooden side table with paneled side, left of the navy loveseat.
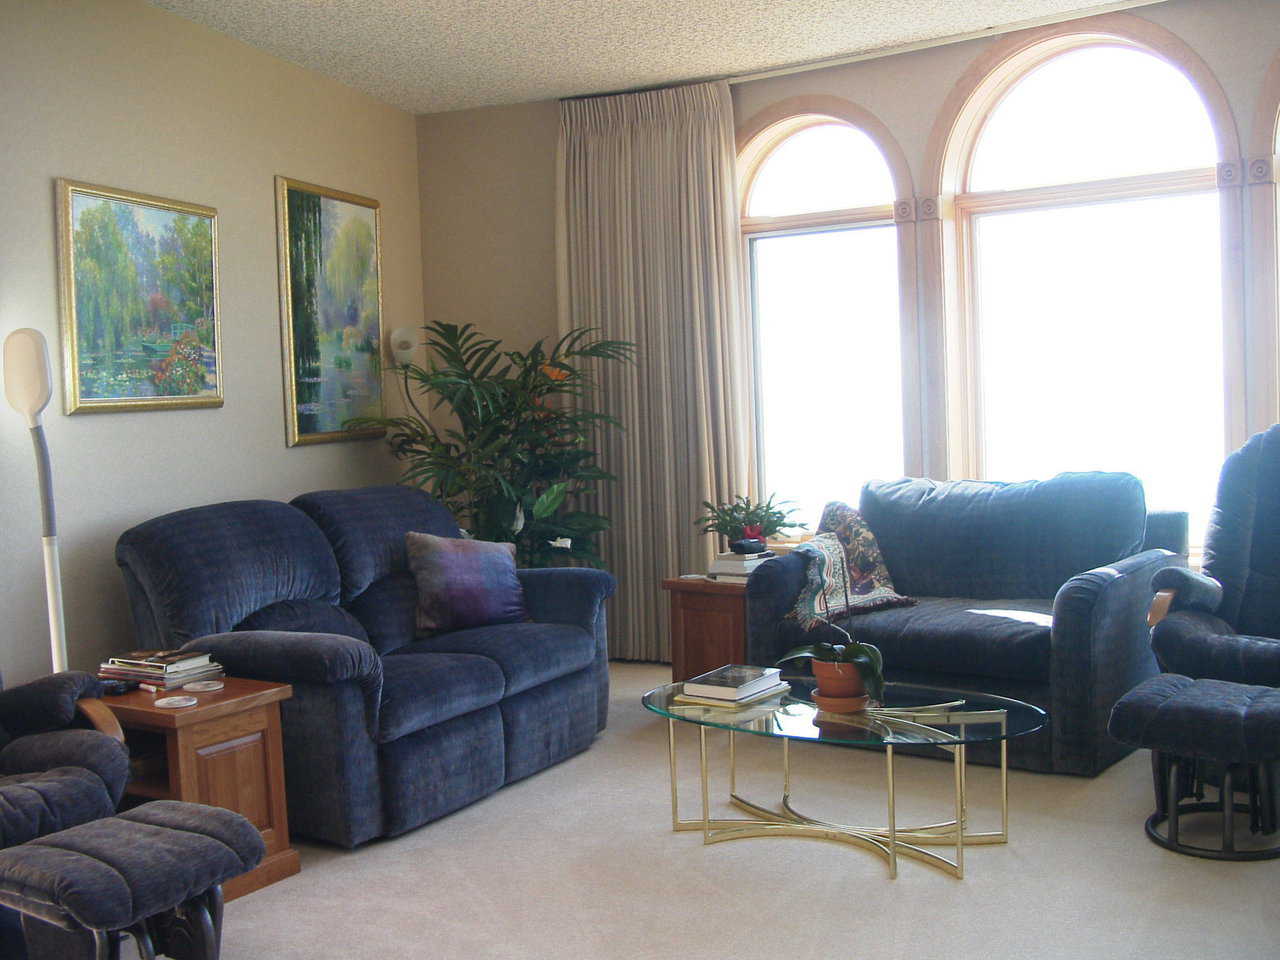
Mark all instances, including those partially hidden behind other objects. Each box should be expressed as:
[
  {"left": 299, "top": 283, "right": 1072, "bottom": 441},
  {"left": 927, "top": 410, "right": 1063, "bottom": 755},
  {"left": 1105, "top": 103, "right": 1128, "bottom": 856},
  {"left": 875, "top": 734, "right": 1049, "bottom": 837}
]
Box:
[{"left": 102, "top": 677, "right": 301, "bottom": 900}]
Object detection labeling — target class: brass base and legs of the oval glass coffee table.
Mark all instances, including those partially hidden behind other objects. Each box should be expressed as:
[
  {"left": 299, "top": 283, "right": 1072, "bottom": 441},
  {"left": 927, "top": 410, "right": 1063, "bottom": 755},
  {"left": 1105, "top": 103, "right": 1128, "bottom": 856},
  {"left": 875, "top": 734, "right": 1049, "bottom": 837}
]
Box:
[{"left": 667, "top": 718, "right": 1009, "bottom": 879}]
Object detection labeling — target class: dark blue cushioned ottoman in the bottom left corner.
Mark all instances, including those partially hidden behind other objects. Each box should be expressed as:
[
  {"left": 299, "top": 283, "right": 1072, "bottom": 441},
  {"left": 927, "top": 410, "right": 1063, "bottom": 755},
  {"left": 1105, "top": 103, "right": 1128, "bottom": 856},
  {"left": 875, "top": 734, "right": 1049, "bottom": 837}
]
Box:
[{"left": 0, "top": 800, "right": 264, "bottom": 960}]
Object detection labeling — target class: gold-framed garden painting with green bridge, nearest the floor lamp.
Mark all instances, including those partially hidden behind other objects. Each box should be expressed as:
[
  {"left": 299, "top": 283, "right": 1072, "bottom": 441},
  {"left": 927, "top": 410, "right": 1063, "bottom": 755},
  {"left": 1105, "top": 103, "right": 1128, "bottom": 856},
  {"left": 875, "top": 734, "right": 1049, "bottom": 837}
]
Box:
[{"left": 58, "top": 179, "right": 223, "bottom": 413}]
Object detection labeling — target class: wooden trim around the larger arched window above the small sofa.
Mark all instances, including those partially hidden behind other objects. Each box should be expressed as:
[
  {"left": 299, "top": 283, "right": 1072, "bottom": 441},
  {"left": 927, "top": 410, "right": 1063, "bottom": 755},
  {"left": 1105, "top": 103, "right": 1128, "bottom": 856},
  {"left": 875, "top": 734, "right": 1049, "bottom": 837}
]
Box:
[{"left": 920, "top": 14, "right": 1244, "bottom": 477}]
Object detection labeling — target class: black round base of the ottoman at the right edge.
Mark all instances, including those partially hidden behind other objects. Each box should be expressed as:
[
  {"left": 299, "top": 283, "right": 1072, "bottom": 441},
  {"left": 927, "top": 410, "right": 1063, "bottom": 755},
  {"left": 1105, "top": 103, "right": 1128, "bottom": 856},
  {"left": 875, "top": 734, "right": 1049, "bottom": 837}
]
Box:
[{"left": 1147, "top": 750, "right": 1280, "bottom": 861}]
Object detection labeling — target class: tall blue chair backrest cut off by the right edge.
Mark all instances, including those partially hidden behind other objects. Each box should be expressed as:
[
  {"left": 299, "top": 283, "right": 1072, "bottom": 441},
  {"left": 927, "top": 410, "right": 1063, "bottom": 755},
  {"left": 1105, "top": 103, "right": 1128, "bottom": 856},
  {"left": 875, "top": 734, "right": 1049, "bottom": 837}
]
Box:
[{"left": 1204, "top": 424, "right": 1280, "bottom": 637}]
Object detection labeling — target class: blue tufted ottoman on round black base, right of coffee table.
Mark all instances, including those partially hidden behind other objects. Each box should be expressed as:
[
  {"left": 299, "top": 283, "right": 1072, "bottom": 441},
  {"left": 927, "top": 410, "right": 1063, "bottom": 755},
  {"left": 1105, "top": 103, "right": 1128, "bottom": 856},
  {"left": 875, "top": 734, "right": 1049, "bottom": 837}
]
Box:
[{"left": 1107, "top": 673, "right": 1280, "bottom": 860}]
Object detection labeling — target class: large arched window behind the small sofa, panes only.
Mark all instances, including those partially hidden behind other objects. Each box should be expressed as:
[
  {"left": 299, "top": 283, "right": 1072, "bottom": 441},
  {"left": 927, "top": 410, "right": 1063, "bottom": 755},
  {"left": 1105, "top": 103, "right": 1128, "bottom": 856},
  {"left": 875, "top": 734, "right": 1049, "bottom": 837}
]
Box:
[{"left": 955, "top": 40, "right": 1228, "bottom": 540}]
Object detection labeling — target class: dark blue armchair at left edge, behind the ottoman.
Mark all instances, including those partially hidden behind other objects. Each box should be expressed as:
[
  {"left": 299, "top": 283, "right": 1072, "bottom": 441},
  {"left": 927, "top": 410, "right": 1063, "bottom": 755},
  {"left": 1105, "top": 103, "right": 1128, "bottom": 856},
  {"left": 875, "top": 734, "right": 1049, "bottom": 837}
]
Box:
[{"left": 0, "top": 672, "right": 129, "bottom": 957}]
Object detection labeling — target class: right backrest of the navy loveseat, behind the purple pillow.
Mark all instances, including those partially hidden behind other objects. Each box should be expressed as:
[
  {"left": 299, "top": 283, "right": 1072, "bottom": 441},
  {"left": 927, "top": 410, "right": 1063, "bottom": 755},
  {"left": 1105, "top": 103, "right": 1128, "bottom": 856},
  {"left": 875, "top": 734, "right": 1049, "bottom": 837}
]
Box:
[{"left": 292, "top": 486, "right": 461, "bottom": 653}]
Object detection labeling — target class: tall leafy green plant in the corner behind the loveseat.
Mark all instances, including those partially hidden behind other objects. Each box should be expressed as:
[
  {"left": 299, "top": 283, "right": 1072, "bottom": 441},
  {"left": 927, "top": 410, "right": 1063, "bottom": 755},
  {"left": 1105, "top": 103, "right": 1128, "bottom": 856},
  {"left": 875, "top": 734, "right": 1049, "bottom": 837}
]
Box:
[{"left": 347, "top": 323, "right": 635, "bottom": 567}]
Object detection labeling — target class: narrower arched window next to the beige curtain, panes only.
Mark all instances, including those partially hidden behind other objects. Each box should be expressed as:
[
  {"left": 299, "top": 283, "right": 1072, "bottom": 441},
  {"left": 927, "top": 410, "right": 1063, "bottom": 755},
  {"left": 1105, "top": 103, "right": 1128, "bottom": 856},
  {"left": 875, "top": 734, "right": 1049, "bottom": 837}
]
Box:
[{"left": 742, "top": 115, "right": 904, "bottom": 529}]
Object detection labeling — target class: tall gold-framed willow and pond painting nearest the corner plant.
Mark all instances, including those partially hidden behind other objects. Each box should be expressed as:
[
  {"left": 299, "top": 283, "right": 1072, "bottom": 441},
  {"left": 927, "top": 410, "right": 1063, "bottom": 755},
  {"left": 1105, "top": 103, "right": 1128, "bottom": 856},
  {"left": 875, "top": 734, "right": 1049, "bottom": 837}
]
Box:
[{"left": 275, "top": 177, "right": 385, "bottom": 447}]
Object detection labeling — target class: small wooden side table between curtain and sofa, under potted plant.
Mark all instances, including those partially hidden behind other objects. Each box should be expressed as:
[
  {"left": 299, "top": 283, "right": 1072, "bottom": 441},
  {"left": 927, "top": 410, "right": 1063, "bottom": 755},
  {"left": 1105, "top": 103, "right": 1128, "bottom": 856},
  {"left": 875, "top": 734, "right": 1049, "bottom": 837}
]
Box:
[{"left": 662, "top": 577, "right": 746, "bottom": 680}]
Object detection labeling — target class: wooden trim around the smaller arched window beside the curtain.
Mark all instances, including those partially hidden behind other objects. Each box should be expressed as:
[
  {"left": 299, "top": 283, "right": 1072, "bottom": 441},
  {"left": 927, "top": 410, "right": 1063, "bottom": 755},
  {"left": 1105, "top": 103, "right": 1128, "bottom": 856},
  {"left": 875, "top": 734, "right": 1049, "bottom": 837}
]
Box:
[{"left": 737, "top": 95, "right": 924, "bottom": 490}]
